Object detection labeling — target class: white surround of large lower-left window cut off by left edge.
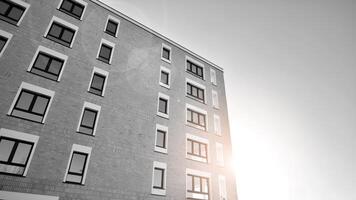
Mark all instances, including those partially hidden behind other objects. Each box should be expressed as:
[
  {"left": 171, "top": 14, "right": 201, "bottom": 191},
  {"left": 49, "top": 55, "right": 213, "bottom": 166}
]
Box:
[{"left": 0, "top": 128, "right": 40, "bottom": 177}]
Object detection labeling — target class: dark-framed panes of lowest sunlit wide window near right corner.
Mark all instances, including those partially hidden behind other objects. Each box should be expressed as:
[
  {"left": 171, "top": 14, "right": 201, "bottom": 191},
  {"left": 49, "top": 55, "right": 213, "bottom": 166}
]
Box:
[{"left": 187, "top": 174, "right": 209, "bottom": 196}]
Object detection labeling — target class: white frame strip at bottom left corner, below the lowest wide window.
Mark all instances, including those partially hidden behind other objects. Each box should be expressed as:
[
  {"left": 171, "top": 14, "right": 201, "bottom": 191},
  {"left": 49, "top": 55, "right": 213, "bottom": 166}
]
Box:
[{"left": 0, "top": 191, "right": 59, "bottom": 200}]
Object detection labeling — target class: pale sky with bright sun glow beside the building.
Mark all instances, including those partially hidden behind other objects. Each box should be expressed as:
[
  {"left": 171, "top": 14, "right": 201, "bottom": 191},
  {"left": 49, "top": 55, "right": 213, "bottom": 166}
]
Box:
[{"left": 98, "top": 0, "right": 356, "bottom": 200}]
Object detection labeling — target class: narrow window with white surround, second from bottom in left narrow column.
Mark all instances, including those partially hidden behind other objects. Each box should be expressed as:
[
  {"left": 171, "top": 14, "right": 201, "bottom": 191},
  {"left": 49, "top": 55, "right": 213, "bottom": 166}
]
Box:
[{"left": 77, "top": 102, "right": 101, "bottom": 135}]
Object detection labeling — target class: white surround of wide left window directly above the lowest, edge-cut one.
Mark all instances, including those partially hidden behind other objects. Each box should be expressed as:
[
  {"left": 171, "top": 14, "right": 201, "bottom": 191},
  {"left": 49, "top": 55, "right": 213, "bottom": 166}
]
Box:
[{"left": 7, "top": 82, "right": 55, "bottom": 124}]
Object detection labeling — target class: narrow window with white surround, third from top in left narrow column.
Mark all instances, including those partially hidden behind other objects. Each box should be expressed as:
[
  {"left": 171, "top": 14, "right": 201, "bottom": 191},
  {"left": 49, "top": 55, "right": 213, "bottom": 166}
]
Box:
[{"left": 88, "top": 67, "right": 109, "bottom": 96}]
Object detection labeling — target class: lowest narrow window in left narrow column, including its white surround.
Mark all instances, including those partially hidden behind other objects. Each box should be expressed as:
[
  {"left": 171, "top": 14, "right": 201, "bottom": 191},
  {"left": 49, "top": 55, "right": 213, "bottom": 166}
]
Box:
[{"left": 63, "top": 144, "right": 91, "bottom": 185}]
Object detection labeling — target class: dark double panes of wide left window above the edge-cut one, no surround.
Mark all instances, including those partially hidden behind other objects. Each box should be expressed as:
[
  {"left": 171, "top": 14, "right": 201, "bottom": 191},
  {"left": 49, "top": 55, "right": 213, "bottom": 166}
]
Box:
[{"left": 11, "top": 90, "right": 51, "bottom": 122}]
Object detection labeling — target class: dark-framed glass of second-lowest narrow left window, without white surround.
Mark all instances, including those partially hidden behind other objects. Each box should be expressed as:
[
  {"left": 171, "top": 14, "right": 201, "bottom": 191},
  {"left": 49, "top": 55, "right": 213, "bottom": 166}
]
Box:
[{"left": 79, "top": 108, "right": 98, "bottom": 135}]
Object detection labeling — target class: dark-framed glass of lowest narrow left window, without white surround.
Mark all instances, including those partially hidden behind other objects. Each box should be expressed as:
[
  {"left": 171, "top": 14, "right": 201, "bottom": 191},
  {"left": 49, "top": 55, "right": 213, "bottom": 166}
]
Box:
[{"left": 66, "top": 152, "right": 88, "bottom": 183}]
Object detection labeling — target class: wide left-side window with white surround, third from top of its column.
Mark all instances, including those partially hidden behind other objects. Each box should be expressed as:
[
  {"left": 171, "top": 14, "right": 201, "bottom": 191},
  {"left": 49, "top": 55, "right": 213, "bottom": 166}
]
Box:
[{"left": 27, "top": 46, "right": 68, "bottom": 81}]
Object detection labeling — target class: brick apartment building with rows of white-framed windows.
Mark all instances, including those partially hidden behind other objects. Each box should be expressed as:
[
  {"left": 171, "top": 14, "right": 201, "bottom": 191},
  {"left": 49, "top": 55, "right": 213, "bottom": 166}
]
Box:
[{"left": 0, "top": 0, "right": 237, "bottom": 200}]
